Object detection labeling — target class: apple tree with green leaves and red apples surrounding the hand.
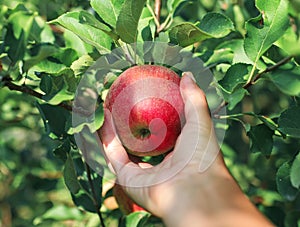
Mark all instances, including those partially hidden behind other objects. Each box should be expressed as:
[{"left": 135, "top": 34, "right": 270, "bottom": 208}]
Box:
[{"left": 0, "top": 0, "right": 300, "bottom": 227}]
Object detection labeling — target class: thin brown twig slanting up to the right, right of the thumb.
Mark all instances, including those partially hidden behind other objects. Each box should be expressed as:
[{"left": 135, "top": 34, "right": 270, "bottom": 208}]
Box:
[{"left": 213, "top": 56, "right": 293, "bottom": 116}]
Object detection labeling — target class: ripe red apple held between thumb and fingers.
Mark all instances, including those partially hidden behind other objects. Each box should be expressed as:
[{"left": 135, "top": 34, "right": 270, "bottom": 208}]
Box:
[{"left": 104, "top": 65, "right": 185, "bottom": 156}]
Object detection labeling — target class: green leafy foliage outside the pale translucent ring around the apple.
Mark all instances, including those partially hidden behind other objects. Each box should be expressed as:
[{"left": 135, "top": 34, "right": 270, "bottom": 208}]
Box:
[{"left": 0, "top": 0, "right": 300, "bottom": 227}]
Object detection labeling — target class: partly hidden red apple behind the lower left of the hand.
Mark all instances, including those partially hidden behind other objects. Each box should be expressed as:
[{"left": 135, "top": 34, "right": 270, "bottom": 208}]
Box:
[{"left": 113, "top": 183, "right": 145, "bottom": 215}]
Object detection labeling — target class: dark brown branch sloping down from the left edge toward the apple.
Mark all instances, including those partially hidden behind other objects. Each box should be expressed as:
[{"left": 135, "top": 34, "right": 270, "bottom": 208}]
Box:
[{"left": 2, "top": 77, "right": 72, "bottom": 111}]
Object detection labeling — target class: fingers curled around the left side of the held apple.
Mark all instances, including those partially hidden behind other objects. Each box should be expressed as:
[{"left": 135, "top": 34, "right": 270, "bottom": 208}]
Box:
[{"left": 100, "top": 109, "right": 130, "bottom": 174}]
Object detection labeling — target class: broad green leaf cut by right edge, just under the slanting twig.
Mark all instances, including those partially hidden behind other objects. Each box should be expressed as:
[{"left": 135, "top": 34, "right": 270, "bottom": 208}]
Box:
[{"left": 268, "top": 66, "right": 300, "bottom": 96}]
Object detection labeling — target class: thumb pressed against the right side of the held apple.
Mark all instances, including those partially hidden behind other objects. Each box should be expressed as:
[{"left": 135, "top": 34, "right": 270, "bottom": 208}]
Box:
[{"left": 172, "top": 72, "right": 219, "bottom": 170}]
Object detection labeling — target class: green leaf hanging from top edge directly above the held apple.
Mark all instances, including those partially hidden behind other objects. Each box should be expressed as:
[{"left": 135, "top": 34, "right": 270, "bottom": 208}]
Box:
[{"left": 116, "top": 0, "right": 146, "bottom": 43}]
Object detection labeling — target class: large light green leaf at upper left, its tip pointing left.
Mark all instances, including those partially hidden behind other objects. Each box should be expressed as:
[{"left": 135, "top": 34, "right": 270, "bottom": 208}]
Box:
[{"left": 51, "top": 12, "right": 112, "bottom": 54}]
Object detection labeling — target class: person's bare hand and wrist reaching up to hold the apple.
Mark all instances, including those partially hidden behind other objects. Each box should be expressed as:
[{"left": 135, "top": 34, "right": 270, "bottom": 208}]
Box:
[{"left": 100, "top": 73, "right": 274, "bottom": 227}]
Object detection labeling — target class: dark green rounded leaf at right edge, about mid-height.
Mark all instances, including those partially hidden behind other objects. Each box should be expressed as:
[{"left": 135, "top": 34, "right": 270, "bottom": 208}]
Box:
[{"left": 278, "top": 106, "right": 300, "bottom": 138}]
